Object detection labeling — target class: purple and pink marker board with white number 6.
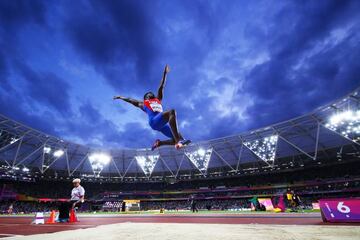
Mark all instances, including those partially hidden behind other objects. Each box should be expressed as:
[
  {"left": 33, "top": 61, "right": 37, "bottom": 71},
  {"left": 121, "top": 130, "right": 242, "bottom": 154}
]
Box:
[{"left": 319, "top": 198, "right": 360, "bottom": 222}]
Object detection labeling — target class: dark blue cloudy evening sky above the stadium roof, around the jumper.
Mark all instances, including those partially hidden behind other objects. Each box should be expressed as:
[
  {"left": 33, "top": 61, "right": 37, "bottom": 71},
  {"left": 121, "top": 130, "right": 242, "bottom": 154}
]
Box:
[{"left": 0, "top": 0, "right": 360, "bottom": 147}]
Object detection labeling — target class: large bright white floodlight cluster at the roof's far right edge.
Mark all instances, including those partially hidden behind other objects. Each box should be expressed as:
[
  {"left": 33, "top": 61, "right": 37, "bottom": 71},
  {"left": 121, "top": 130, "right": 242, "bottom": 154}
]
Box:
[{"left": 325, "top": 110, "right": 360, "bottom": 142}]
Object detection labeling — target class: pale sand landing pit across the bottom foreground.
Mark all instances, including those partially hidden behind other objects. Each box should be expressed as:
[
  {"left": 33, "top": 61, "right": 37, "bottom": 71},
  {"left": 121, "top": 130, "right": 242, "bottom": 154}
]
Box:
[{"left": 6, "top": 222, "right": 360, "bottom": 240}]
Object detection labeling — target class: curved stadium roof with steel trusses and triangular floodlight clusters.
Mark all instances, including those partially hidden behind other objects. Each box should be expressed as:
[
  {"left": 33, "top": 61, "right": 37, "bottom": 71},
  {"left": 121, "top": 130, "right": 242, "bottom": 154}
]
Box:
[{"left": 0, "top": 88, "right": 360, "bottom": 180}]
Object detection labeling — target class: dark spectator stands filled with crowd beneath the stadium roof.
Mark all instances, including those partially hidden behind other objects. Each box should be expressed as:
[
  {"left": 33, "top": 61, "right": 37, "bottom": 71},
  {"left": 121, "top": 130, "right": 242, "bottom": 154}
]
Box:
[{"left": 0, "top": 163, "right": 360, "bottom": 214}]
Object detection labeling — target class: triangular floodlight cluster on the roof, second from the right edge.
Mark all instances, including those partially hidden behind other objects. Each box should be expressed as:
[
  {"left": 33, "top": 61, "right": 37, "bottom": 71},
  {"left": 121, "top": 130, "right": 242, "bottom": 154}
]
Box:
[{"left": 244, "top": 135, "right": 278, "bottom": 162}]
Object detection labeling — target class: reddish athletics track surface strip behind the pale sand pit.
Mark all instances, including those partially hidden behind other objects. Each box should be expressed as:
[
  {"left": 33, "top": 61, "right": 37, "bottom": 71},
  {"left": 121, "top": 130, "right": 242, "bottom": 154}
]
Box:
[{"left": 0, "top": 213, "right": 354, "bottom": 237}]
